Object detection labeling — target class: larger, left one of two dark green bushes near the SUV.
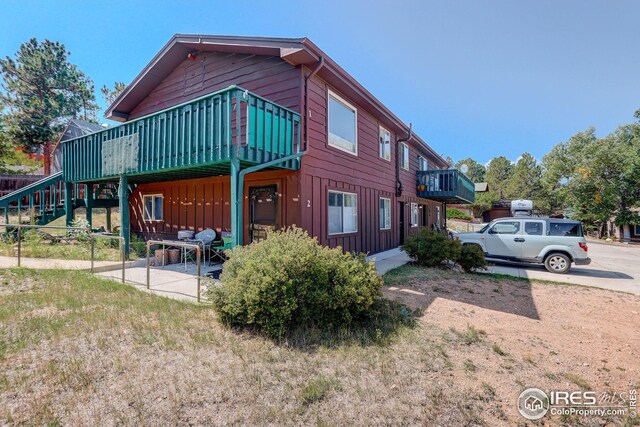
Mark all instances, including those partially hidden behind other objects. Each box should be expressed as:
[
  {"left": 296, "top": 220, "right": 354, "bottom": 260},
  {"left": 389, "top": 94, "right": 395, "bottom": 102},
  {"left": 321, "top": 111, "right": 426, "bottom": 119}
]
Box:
[{"left": 402, "top": 228, "right": 461, "bottom": 267}]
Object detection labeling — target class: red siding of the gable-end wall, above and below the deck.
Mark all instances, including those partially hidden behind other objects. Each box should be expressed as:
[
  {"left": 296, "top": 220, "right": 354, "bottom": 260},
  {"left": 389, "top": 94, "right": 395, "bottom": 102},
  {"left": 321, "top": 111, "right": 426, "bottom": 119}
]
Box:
[{"left": 129, "top": 52, "right": 302, "bottom": 243}]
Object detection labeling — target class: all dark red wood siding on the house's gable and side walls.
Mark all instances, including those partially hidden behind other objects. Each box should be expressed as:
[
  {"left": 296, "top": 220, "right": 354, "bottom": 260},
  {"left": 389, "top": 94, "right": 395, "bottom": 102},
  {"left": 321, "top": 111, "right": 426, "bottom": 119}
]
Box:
[{"left": 124, "top": 52, "right": 444, "bottom": 253}]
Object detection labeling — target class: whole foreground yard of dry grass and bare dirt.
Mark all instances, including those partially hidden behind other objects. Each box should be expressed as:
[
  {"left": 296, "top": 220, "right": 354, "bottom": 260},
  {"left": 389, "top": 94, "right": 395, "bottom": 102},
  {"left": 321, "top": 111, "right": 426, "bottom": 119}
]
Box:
[{"left": 0, "top": 267, "right": 640, "bottom": 426}]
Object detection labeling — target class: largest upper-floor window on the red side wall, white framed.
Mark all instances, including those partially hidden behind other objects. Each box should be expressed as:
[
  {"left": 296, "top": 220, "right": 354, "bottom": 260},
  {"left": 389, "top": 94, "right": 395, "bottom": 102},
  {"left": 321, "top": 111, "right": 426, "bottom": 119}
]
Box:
[{"left": 327, "top": 91, "right": 358, "bottom": 156}]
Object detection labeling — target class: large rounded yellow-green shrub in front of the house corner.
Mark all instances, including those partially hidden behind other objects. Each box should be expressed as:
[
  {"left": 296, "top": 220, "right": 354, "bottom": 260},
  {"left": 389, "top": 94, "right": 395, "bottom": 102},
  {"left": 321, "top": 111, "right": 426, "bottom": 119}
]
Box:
[{"left": 207, "top": 228, "right": 382, "bottom": 337}]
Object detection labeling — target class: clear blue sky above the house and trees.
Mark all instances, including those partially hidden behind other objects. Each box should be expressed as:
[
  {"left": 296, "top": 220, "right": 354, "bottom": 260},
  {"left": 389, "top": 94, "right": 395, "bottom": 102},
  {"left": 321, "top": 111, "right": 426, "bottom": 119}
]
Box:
[{"left": 0, "top": 0, "right": 640, "bottom": 163}]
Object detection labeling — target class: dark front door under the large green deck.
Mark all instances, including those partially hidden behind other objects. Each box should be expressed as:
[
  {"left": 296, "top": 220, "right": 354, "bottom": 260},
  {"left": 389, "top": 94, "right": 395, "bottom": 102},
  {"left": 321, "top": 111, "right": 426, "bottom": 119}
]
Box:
[{"left": 249, "top": 185, "right": 278, "bottom": 242}]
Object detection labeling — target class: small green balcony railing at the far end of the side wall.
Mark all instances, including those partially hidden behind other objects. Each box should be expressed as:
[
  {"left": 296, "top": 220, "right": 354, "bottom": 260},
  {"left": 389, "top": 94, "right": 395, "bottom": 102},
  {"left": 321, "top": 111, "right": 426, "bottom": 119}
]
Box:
[{"left": 416, "top": 169, "right": 475, "bottom": 203}]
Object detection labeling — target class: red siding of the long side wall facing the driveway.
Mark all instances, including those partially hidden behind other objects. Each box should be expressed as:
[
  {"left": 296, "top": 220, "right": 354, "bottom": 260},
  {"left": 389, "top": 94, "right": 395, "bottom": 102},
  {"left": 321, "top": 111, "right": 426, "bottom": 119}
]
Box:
[{"left": 300, "top": 71, "right": 444, "bottom": 253}]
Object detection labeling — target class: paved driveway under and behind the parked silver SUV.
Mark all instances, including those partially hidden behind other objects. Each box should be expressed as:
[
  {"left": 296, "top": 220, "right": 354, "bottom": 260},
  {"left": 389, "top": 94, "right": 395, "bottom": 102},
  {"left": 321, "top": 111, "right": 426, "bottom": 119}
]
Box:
[{"left": 489, "top": 241, "right": 640, "bottom": 295}]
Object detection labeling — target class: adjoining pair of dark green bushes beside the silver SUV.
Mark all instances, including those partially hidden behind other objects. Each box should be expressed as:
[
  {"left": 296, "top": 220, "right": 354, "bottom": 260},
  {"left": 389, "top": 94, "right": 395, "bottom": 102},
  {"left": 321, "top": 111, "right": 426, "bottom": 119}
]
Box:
[{"left": 402, "top": 229, "right": 487, "bottom": 272}]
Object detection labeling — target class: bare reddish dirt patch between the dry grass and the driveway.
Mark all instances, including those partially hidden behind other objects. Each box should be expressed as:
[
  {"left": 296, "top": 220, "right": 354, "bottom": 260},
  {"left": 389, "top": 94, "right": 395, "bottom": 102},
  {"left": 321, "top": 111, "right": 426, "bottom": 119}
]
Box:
[{"left": 385, "top": 267, "right": 640, "bottom": 425}]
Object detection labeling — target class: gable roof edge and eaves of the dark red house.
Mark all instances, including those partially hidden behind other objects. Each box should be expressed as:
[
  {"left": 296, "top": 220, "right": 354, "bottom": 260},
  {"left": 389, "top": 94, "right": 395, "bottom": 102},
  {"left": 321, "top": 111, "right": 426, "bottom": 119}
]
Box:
[{"left": 105, "top": 34, "right": 448, "bottom": 165}]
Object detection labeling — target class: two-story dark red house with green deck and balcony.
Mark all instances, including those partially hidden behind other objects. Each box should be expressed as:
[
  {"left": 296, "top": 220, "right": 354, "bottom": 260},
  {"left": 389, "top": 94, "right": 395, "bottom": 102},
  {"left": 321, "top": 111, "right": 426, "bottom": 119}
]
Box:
[{"left": 0, "top": 34, "right": 474, "bottom": 253}]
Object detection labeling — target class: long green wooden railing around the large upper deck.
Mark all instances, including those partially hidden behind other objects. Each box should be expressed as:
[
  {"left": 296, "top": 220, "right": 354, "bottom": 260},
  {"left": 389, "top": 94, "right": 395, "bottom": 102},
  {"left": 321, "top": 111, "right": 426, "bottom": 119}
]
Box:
[{"left": 63, "top": 86, "right": 302, "bottom": 182}]
